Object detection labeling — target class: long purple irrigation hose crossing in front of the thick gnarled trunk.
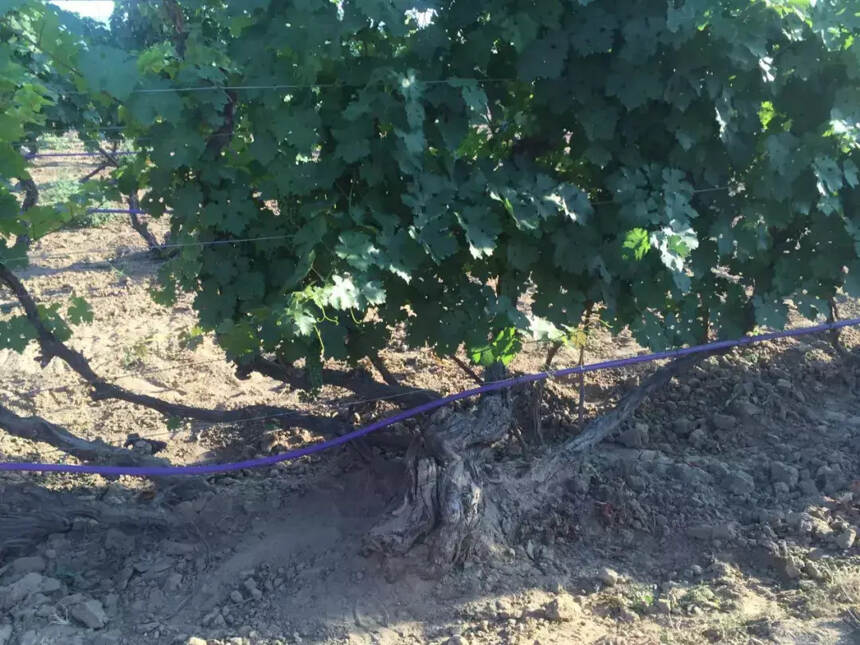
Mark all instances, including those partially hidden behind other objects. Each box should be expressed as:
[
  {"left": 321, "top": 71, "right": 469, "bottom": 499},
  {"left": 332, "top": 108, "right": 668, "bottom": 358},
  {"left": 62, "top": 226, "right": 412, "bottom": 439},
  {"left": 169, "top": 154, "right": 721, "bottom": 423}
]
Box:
[{"left": 0, "top": 318, "right": 860, "bottom": 477}]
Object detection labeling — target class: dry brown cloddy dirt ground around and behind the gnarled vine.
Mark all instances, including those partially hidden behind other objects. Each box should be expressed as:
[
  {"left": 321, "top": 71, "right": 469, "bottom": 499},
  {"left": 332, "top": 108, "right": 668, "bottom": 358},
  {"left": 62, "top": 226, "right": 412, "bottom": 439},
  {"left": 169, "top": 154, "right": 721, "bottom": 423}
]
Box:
[{"left": 0, "top": 153, "right": 860, "bottom": 645}]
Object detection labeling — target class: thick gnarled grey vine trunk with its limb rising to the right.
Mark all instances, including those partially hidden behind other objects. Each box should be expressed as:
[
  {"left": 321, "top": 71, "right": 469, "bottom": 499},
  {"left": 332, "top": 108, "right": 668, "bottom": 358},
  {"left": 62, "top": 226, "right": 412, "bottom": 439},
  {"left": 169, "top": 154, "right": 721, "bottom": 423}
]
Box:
[{"left": 365, "top": 352, "right": 713, "bottom": 573}]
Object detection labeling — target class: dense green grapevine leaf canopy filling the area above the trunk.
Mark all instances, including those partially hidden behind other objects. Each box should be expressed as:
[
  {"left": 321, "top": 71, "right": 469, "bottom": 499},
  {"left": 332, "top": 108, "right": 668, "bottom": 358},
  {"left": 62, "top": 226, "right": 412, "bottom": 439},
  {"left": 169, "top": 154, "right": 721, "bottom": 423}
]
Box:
[{"left": 0, "top": 0, "right": 860, "bottom": 382}]
